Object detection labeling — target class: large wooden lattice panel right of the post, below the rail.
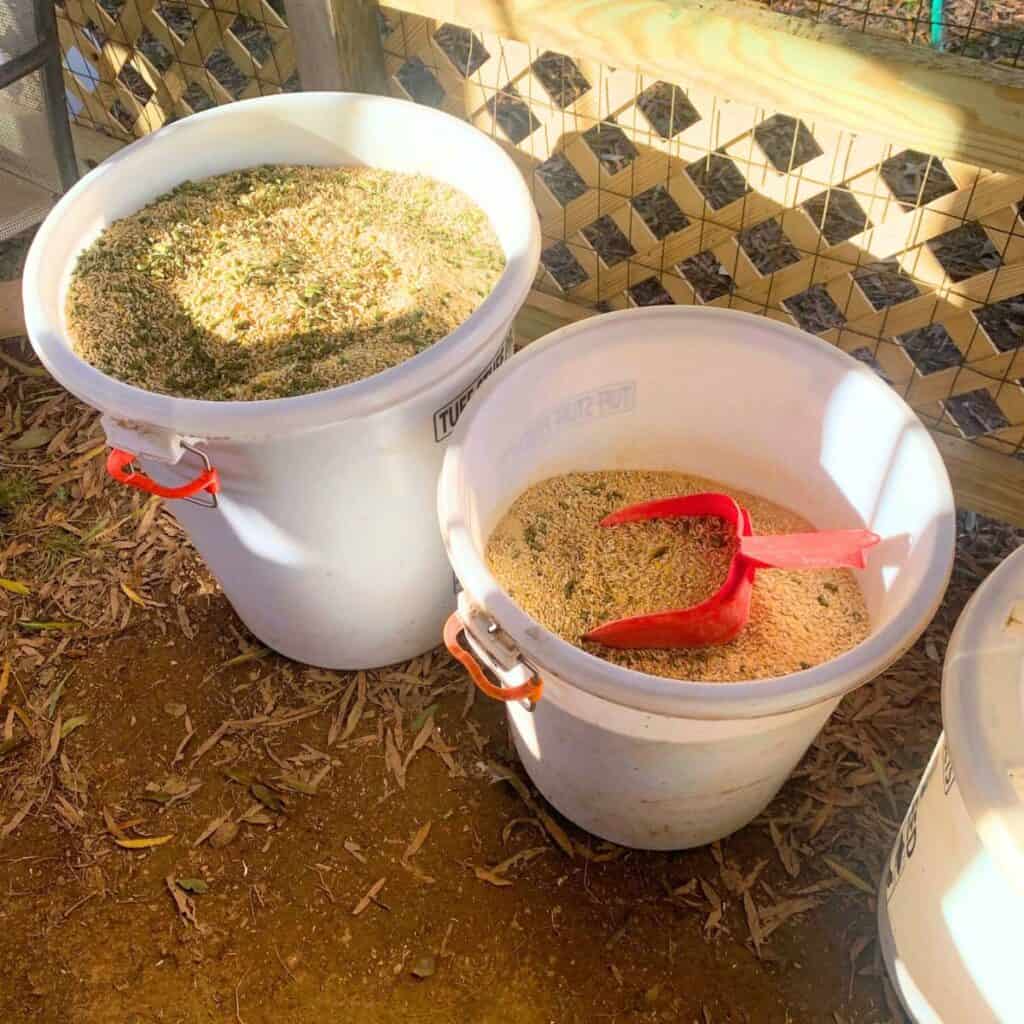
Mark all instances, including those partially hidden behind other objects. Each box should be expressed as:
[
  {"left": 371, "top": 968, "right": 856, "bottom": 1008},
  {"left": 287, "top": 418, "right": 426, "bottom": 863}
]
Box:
[{"left": 383, "top": 9, "right": 1024, "bottom": 456}]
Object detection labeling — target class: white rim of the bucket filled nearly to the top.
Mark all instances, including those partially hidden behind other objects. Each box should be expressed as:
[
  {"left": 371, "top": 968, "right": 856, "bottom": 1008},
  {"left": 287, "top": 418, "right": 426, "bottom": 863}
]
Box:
[{"left": 22, "top": 91, "right": 541, "bottom": 438}]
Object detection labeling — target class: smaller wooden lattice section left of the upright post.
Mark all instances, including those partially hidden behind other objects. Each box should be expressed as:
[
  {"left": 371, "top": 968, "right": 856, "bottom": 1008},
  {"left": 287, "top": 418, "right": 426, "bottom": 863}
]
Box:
[{"left": 57, "top": 0, "right": 298, "bottom": 138}]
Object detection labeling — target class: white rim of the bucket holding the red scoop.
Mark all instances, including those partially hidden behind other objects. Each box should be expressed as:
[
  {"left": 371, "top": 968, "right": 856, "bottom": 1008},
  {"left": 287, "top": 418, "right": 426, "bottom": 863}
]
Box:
[{"left": 437, "top": 306, "right": 956, "bottom": 720}]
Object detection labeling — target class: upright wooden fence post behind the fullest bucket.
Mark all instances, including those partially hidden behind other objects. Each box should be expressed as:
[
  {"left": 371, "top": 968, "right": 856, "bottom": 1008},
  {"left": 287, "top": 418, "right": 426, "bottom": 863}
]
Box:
[{"left": 285, "top": 0, "right": 387, "bottom": 95}]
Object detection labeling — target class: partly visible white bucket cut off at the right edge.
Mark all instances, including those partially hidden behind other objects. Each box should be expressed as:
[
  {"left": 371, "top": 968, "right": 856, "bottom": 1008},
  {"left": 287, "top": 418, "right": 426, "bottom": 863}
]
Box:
[{"left": 879, "top": 549, "right": 1024, "bottom": 1024}]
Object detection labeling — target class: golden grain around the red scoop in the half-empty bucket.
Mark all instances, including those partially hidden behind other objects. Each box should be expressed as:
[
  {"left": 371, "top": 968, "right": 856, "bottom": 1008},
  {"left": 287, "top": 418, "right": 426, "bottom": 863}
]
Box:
[{"left": 486, "top": 470, "right": 870, "bottom": 682}]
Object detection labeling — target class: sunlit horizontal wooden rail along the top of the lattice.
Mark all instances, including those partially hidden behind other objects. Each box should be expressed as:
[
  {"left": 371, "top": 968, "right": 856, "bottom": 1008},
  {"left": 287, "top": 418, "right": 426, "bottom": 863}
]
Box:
[{"left": 385, "top": 0, "right": 1024, "bottom": 173}]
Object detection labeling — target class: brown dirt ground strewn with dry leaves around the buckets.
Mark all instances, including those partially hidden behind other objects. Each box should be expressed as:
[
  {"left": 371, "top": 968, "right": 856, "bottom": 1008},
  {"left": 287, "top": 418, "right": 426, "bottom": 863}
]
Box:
[{"left": 0, "top": 228, "right": 1024, "bottom": 1024}]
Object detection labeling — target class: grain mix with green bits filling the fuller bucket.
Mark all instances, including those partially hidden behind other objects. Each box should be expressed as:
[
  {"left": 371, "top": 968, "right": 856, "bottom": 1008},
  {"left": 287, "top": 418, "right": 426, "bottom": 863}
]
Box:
[{"left": 67, "top": 166, "right": 505, "bottom": 400}]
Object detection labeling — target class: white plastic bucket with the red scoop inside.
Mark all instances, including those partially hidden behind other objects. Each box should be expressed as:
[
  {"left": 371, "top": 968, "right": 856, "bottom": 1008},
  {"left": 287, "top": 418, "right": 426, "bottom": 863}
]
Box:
[{"left": 438, "top": 306, "right": 954, "bottom": 849}]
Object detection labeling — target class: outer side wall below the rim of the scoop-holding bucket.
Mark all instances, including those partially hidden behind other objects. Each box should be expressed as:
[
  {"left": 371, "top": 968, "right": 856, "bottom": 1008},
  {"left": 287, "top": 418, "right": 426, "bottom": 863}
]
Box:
[{"left": 509, "top": 676, "right": 838, "bottom": 850}]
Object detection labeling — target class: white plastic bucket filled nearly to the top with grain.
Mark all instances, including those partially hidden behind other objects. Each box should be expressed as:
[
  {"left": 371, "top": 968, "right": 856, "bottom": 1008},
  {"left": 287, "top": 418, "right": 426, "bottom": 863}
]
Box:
[{"left": 25, "top": 93, "right": 540, "bottom": 669}]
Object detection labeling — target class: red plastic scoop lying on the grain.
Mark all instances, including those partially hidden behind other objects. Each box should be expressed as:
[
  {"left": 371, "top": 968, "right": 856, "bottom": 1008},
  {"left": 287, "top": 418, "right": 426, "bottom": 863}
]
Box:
[{"left": 585, "top": 493, "right": 880, "bottom": 648}]
